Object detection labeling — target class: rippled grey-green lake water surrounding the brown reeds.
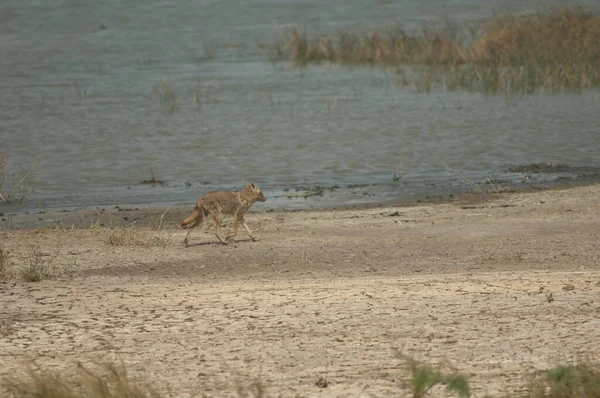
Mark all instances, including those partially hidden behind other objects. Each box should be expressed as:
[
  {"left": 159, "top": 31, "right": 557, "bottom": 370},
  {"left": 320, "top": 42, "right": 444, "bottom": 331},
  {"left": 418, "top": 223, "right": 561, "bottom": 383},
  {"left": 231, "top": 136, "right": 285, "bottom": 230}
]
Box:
[{"left": 0, "top": 0, "right": 600, "bottom": 212}]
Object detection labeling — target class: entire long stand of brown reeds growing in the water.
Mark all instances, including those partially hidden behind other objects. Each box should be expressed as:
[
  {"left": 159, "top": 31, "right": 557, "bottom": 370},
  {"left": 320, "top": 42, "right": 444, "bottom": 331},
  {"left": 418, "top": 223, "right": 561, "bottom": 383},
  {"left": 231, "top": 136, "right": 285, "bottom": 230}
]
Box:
[{"left": 272, "top": 8, "right": 600, "bottom": 94}]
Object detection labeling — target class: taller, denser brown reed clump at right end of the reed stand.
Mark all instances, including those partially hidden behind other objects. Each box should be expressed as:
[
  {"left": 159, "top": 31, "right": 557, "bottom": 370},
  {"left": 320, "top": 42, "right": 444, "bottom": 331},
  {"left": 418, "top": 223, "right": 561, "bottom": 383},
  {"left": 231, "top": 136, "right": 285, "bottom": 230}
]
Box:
[{"left": 470, "top": 8, "right": 600, "bottom": 92}]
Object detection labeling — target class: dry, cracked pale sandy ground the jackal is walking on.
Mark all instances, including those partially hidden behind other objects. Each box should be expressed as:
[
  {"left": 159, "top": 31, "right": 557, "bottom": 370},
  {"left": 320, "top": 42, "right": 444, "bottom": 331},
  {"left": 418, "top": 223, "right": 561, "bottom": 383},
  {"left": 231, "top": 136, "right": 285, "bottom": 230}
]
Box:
[{"left": 0, "top": 185, "right": 600, "bottom": 397}]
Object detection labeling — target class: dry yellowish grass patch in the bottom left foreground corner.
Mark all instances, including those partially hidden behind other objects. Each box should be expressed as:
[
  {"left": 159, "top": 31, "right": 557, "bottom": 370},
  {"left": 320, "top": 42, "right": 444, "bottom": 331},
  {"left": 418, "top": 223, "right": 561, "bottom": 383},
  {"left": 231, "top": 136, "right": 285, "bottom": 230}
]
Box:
[{"left": 2, "top": 363, "right": 161, "bottom": 398}]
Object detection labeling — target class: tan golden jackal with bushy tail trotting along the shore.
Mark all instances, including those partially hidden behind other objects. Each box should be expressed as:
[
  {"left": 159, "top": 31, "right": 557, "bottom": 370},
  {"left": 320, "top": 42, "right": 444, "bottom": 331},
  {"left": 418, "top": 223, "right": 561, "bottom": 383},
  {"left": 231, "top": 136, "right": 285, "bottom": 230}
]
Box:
[{"left": 181, "top": 183, "right": 267, "bottom": 245}]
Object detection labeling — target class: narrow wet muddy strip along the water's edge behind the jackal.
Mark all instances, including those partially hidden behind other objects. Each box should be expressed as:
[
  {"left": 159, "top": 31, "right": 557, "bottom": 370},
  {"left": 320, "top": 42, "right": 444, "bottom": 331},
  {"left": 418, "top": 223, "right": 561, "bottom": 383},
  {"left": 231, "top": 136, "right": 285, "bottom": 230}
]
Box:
[{"left": 0, "top": 162, "right": 600, "bottom": 226}]
